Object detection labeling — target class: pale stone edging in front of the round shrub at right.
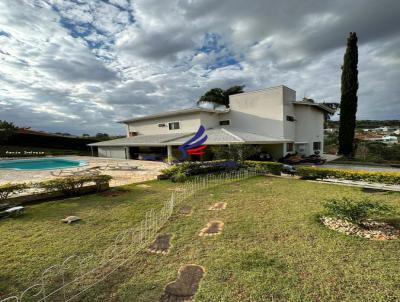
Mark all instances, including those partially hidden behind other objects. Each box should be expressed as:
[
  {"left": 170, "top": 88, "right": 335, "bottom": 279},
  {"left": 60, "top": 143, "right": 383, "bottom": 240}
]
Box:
[{"left": 321, "top": 217, "right": 400, "bottom": 240}]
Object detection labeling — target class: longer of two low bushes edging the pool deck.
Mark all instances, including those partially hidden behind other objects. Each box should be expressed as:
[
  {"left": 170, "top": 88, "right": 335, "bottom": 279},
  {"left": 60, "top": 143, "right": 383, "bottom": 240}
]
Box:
[{"left": 35, "top": 175, "right": 112, "bottom": 195}]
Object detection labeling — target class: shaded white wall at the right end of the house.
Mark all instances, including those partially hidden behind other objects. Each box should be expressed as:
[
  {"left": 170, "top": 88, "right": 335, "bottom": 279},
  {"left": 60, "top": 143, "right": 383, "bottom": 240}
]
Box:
[{"left": 294, "top": 105, "right": 324, "bottom": 155}]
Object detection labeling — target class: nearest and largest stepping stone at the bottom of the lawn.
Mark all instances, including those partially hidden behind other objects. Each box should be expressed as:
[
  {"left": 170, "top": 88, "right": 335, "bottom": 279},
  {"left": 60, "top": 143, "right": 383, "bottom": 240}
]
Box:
[{"left": 160, "top": 264, "right": 204, "bottom": 302}]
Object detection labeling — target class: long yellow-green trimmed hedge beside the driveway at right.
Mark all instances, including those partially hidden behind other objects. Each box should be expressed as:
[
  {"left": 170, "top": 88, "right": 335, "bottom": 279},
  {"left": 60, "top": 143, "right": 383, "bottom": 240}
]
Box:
[{"left": 297, "top": 167, "right": 400, "bottom": 185}]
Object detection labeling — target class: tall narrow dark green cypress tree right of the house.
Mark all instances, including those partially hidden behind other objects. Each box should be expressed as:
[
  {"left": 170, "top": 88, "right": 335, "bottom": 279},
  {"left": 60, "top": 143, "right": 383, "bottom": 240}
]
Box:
[{"left": 339, "top": 32, "right": 358, "bottom": 157}]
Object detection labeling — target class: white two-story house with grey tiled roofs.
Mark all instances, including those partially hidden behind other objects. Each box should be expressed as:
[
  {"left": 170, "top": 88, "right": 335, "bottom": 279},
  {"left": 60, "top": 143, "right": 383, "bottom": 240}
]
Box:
[{"left": 89, "top": 86, "right": 334, "bottom": 160}]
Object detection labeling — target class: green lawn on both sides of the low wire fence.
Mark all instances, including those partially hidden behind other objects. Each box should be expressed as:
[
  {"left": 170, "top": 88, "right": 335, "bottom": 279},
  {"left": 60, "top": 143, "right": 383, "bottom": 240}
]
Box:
[{"left": 0, "top": 177, "right": 400, "bottom": 302}]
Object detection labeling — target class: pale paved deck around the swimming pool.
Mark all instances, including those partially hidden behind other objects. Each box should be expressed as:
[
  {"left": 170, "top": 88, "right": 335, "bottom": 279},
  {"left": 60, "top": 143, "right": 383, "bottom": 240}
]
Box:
[{"left": 0, "top": 156, "right": 168, "bottom": 187}]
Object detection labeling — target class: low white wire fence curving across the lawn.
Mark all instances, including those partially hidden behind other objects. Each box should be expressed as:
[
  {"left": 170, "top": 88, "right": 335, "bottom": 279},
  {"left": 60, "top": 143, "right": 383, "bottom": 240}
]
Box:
[{"left": 0, "top": 170, "right": 265, "bottom": 302}]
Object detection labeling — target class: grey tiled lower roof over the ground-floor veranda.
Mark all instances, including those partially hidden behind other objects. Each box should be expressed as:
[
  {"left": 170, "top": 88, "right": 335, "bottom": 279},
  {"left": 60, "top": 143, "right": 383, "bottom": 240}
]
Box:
[{"left": 89, "top": 128, "right": 289, "bottom": 147}]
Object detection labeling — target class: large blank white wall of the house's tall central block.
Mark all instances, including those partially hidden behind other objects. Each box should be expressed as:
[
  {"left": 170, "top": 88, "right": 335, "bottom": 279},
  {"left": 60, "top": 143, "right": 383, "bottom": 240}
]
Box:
[{"left": 225, "top": 86, "right": 284, "bottom": 138}]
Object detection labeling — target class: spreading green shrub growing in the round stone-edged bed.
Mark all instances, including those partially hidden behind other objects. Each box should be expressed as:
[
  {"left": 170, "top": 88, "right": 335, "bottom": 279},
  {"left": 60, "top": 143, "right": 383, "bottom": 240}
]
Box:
[{"left": 324, "top": 198, "right": 393, "bottom": 224}]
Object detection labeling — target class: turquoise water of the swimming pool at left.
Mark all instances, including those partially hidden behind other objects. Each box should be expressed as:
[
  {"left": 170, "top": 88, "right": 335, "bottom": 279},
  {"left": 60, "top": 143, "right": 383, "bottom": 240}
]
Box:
[{"left": 0, "top": 158, "right": 86, "bottom": 170}]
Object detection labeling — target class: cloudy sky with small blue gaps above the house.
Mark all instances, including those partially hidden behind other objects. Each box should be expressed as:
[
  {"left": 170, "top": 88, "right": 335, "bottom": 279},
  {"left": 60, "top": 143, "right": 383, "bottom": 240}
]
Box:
[{"left": 0, "top": 0, "right": 400, "bottom": 134}]
